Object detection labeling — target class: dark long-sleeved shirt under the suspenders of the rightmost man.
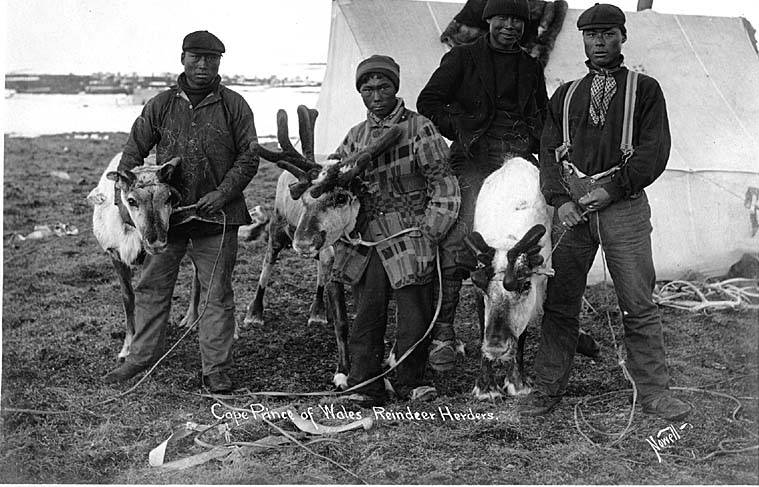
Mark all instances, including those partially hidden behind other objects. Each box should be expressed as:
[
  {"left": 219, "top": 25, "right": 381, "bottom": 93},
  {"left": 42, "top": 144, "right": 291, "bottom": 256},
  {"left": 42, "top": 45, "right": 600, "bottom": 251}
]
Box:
[{"left": 540, "top": 68, "right": 671, "bottom": 208}]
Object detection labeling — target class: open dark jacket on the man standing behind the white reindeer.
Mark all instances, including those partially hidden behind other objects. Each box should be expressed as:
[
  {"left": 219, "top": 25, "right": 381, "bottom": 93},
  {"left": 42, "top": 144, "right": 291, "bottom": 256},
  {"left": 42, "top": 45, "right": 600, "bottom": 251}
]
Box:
[{"left": 416, "top": 34, "right": 548, "bottom": 154}]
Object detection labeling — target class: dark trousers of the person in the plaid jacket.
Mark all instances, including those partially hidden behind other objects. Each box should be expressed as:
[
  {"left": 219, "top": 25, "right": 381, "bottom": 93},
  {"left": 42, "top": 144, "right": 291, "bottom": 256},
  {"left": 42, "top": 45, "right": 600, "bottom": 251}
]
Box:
[{"left": 348, "top": 249, "right": 433, "bottom": 396}]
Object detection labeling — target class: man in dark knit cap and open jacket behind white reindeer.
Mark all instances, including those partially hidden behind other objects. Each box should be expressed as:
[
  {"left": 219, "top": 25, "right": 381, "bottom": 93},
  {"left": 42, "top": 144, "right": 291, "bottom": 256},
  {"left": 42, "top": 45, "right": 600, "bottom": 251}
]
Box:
[{"left": 417, "top": 0, "right": 548, "bottom": 371}]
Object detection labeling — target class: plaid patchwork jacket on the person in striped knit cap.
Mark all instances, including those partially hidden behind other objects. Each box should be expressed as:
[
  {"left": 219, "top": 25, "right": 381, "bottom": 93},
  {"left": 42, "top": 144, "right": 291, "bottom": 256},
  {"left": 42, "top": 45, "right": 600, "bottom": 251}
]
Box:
[{"left": 332, "top": 99, "right": 461, "bottom": 289}]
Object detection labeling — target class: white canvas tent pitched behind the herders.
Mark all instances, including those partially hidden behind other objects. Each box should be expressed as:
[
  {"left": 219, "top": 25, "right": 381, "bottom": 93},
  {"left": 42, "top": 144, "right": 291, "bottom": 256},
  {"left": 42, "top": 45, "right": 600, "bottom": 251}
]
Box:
[{"left": 315, "top": 0, "right": 759, "bottom": 282}]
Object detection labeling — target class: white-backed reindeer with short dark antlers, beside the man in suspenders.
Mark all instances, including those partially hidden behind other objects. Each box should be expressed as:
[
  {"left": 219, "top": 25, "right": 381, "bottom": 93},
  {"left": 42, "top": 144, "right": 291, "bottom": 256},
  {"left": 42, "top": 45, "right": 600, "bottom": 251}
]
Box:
[{"left": 470, "top": 157, "right": 599, "bottom": 399}]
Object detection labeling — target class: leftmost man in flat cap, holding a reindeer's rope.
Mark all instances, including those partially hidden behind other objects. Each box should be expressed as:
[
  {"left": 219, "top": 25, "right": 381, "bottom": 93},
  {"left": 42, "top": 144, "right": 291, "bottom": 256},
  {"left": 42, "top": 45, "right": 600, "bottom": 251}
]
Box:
[{"left": 105, "top": 31, "right": 258, "bottom": 393}]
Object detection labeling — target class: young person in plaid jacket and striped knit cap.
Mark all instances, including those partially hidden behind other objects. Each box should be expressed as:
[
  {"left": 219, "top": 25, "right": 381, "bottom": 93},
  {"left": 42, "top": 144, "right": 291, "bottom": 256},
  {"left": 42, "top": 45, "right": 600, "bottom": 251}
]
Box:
[{"left": 331, "top": 55, "right": 461, "bottom": 406}]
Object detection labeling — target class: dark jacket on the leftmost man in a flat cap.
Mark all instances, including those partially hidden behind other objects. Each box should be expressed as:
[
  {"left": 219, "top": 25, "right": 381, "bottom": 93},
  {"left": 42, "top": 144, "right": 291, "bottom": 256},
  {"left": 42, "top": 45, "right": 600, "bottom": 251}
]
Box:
[{"left": 119, "top": 85, "right": 258, "bottom": 225}]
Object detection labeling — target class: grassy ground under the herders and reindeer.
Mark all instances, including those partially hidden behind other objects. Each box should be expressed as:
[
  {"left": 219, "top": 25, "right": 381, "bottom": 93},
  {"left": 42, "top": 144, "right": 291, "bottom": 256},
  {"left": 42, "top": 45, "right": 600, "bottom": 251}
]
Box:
[{"left": 0, "top": 134, "right": 759, "bottom": 484}]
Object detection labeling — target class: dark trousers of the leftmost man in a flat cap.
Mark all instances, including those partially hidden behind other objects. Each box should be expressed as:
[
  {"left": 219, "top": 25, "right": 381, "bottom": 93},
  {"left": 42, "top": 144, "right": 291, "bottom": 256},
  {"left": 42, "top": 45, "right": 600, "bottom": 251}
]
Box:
[{"left": 127, "top": 226, "right": 237, "bottom": 375}]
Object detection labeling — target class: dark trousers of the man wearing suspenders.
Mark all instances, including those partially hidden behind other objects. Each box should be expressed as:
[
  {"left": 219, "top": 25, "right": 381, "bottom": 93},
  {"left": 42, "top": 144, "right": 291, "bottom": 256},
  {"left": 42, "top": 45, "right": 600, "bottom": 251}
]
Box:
[{"left": 535, "top": 193, "right": 669, "bottom": 399}]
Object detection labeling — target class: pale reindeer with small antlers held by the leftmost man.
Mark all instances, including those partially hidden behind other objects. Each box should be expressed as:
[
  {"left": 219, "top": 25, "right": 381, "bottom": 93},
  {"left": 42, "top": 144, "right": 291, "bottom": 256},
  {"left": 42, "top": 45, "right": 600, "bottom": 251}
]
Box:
[{"left": 87, "top": 153, "right": 180, "bottom": 360}]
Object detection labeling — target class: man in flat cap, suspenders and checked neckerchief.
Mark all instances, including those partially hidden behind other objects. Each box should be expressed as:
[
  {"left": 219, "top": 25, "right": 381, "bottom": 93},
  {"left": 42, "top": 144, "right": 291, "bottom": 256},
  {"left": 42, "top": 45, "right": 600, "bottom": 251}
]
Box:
[{"left": 519, "top": 4, "right": 691, "bottom": 421}]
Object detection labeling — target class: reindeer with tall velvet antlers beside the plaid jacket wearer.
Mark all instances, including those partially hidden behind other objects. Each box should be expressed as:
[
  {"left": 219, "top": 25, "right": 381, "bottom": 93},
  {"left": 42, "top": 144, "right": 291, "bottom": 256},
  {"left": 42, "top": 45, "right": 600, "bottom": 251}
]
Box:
[{"left": 245, "top": 105, "right": 401, "bottom": 388}]
